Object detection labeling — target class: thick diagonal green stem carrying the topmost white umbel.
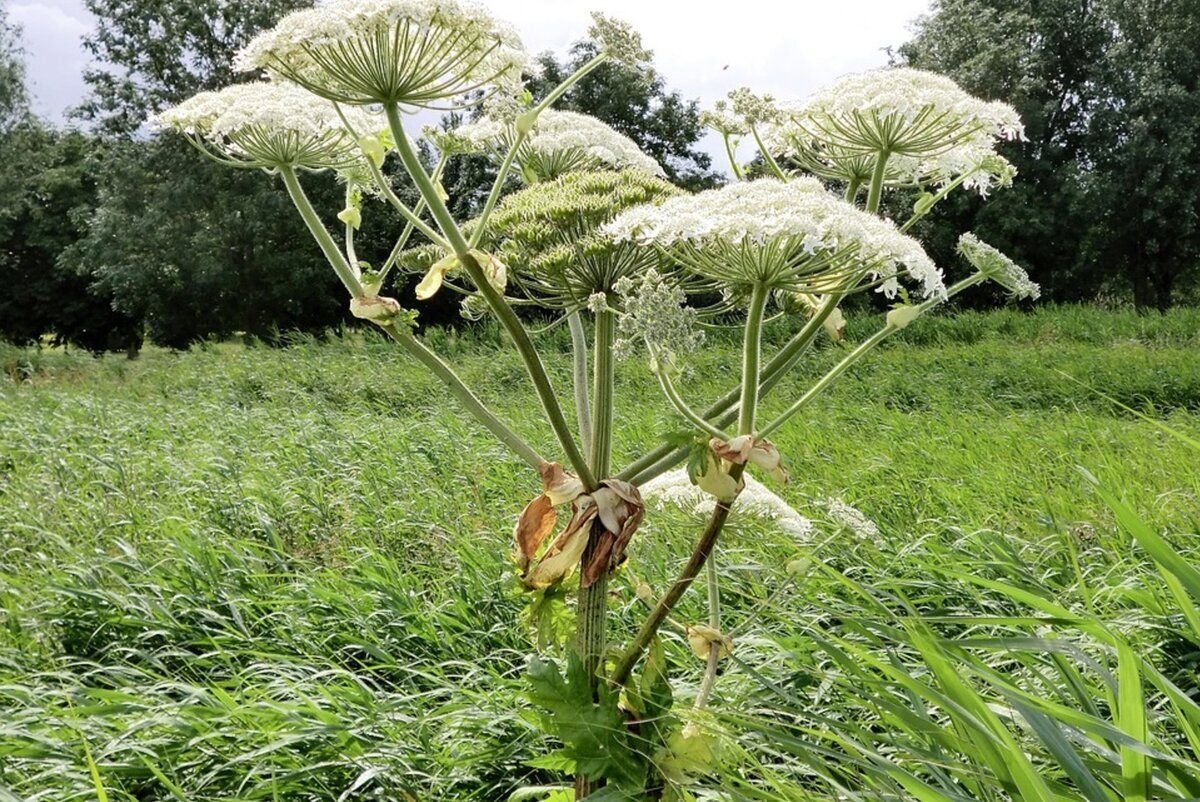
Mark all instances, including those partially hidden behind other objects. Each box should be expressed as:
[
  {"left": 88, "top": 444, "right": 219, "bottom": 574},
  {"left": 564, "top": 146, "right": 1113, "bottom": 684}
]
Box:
[{"left": 384, "top": 103, "right": 596, "bottom": 490}]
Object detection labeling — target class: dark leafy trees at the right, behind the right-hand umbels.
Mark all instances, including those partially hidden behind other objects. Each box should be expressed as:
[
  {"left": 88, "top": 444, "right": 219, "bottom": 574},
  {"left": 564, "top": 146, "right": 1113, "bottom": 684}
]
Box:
[{"left": 895, "top": 0, "right": 1200, "bottom": 309}]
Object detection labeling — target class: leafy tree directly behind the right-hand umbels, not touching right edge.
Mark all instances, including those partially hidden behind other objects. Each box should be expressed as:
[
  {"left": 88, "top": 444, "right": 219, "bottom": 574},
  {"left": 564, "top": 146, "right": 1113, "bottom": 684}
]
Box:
[{"left": 898, "top": 0, "right": 1108, "bottom": 300}]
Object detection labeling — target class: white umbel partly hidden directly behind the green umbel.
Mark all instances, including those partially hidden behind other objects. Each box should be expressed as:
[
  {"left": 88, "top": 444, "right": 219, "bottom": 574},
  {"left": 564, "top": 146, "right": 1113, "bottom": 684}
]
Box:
[{"left": 450, "top": 109, "right": 666, "bottom": 181}]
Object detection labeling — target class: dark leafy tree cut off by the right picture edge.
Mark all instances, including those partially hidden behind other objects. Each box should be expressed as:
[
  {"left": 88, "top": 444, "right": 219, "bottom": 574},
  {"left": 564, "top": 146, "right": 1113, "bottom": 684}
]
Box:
[{"left": 1085, "top": 0, "right": 1200, "bottom": 310}]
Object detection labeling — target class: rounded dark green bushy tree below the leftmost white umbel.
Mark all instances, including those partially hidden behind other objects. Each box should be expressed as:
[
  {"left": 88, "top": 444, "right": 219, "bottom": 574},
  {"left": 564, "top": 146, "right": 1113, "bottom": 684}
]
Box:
[{"left": 64, "top": 137, "right": 352, "bottom": 348}]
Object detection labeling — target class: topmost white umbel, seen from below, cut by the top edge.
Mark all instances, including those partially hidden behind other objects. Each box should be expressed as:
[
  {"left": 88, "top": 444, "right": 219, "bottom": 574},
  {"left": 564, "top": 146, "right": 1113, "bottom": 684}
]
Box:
[{"left": 236, "top": 0, "right": 530, "bottom": 108}]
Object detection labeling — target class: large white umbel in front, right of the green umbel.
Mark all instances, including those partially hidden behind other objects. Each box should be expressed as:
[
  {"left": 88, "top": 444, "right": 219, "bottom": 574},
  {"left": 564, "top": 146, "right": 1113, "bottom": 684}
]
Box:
[{"left": 605, "top": 178, "right": 946, "bottom": 297}]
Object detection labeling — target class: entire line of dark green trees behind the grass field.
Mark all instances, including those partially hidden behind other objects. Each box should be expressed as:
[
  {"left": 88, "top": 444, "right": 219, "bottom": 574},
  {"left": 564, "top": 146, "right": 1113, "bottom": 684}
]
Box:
[{"left": 0, "top": 0, "right": 1200, "bottom": 353}]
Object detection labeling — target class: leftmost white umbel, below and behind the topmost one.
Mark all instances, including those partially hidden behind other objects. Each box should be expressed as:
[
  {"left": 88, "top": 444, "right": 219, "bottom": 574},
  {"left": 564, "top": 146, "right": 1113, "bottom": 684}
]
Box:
[{"left": 152, "top": 82, "right": 388, "bottom": 169}]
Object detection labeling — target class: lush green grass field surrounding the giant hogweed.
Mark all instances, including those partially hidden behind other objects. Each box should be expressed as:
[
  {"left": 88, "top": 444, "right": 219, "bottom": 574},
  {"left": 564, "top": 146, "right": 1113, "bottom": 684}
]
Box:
[{"left": 0, "top": 307, "right": 1200, "bottom": 802}]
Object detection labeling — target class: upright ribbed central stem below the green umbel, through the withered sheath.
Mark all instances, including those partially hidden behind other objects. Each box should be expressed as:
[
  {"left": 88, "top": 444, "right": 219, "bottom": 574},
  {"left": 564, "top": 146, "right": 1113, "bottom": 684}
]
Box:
[{"left": 575, "top": 304, "right": 617, "bottom": 798}]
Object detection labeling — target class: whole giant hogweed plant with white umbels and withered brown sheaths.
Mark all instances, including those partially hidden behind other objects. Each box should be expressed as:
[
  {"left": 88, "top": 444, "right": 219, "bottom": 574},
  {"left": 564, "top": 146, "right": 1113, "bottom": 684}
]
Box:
[{"left": 157, "top": 0, "right": 1037, "bottom": 800}]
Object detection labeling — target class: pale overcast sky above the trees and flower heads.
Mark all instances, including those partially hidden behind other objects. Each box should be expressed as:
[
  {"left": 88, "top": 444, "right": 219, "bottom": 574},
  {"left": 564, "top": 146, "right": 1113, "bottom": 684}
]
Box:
[{"left": 9, "top": 0, "right": 929, "bottom": 164}]
